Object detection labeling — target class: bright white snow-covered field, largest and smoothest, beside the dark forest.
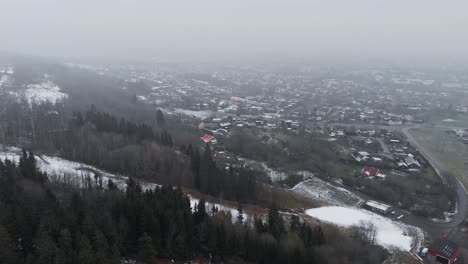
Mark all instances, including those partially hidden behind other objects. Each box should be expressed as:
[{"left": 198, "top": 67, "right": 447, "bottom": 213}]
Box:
[{"left": 306, "top": 206, "right": 423, "bottom": 251}]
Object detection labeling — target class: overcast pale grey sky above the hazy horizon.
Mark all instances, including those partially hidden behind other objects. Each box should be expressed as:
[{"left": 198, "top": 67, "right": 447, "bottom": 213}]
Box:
[{"left": 0, "top": 0, "right": 468, "bottom": 61}]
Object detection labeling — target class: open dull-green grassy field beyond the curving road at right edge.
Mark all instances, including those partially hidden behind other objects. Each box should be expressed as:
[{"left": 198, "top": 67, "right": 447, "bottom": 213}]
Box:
[{"left": 409, "top": 128, "right": 468, "bottom": 188}]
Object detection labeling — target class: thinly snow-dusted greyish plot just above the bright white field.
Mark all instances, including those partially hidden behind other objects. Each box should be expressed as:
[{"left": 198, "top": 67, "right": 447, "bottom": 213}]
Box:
[{"left": 291, "top": 177, "right": 364, "bottom": 206}]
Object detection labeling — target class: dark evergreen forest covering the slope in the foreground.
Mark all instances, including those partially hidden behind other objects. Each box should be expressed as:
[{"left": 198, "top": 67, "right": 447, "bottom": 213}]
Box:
[{"left": 0, "top": 152, "right": 385, "bottom": 264}]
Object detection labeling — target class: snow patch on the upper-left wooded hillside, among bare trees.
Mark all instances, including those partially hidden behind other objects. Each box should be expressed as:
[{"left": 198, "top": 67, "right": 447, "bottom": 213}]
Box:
[{"left": 24, "top": 81, "right": 68, "bottom": 105}]
